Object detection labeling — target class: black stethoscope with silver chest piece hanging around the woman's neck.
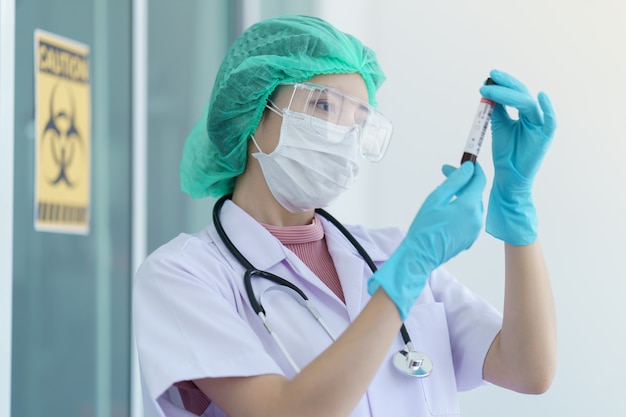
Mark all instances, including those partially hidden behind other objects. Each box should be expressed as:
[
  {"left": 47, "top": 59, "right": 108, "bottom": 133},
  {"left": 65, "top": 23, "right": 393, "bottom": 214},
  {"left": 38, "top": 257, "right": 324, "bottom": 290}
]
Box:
[{"left": 213, "top": 195, "right": 433, "bottom": 378}]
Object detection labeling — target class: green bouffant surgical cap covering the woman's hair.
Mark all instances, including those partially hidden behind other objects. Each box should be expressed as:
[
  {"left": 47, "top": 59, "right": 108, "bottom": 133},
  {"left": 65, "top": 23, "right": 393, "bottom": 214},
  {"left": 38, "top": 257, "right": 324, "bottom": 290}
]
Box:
[{"left": 180, "top": 15, "right": 385, "bottom": 198}]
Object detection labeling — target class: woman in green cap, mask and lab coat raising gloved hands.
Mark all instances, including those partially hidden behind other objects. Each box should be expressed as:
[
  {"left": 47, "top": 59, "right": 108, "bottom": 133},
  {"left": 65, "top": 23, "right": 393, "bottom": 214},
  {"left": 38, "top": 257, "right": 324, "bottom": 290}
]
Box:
[{"left": 133, "top": 16, "right": 556, "bottom": 417}]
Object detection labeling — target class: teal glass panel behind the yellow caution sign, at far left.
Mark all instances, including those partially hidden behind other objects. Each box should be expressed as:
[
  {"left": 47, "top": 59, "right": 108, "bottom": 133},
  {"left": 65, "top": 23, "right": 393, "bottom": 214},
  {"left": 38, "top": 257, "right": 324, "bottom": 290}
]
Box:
[{"left": 11, "top": 0, "right": 131, "bottom": 417}]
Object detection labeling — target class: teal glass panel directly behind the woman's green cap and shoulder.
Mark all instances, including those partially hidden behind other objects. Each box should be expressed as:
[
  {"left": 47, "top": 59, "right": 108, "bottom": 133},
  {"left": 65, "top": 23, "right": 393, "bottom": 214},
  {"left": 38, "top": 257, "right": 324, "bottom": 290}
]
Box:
[{"left": 148, "top": 0, "right": 230, "bottom": 252}]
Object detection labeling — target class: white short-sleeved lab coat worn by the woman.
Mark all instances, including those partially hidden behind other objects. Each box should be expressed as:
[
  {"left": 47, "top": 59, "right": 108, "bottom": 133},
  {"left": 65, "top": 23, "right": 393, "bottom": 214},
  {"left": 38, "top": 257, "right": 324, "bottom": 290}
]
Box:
[{"left": 133, "top": 201, "right": 502, "bottom": 417}]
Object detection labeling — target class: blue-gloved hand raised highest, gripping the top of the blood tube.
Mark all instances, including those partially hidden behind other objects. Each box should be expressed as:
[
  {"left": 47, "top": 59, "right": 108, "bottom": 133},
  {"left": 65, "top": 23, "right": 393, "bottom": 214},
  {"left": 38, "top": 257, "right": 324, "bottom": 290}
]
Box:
[{"left": 480, "top": 70, "right": 556, "bottom": 245}]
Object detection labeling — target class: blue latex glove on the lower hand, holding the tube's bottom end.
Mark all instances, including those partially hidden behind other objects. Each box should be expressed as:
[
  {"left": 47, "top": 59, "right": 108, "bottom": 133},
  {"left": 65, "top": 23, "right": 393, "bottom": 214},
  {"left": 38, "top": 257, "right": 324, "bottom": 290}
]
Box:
[{"left": 368, "top": 162, "right": 486, "bottom": 321}]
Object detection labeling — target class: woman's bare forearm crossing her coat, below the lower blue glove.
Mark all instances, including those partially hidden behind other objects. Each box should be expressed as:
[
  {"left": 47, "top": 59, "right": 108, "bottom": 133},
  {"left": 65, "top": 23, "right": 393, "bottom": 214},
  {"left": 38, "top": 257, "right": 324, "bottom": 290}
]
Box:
[{"left": 195, "top": 289, "right": 402, "bottom": 417}]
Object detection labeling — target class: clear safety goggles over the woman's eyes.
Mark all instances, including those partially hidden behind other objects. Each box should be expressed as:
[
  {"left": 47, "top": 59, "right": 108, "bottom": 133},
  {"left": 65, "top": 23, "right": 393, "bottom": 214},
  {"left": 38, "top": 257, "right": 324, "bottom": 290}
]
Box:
[{"left": 271, "top": 83, "right": 393, "bottom": 162}]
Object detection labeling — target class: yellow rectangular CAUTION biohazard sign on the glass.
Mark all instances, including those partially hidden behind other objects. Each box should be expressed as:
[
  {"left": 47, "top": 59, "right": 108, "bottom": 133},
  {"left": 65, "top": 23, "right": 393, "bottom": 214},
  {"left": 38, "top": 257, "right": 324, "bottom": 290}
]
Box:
[{"left": 35, "top": 30, "right": 91, "bottom": 234}]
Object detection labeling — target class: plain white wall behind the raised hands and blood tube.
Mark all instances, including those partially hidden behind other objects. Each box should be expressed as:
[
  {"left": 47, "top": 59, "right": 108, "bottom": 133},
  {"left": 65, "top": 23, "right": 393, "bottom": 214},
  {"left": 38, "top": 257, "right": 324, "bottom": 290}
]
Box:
[{"left": 320, "top": 0, "right": 626, "bottom": 417}]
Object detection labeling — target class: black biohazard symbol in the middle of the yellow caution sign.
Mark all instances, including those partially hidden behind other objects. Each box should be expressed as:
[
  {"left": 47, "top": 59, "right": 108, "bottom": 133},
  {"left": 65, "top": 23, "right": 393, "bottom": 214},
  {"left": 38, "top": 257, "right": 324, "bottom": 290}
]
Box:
[{"left": 42, "top": 83, "right": 83, "bottom": 188}]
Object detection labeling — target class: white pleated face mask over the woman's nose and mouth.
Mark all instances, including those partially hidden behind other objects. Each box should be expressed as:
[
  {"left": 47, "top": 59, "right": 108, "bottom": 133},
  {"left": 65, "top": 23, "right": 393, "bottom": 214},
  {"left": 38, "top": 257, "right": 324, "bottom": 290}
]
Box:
[{"left": 252, "top": 109, "right": 359, "bottom": 213}]
